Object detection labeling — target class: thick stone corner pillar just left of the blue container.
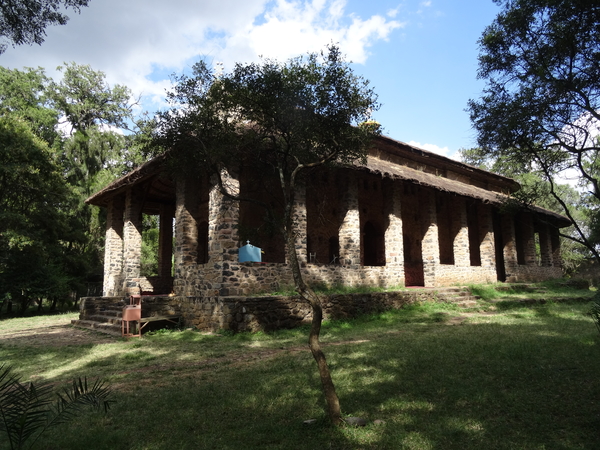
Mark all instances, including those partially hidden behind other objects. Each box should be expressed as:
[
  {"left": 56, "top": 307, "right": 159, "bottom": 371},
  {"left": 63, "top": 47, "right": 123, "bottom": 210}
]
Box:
[{"left": 208, "top": 172, "right": 240, "bottom": 296}]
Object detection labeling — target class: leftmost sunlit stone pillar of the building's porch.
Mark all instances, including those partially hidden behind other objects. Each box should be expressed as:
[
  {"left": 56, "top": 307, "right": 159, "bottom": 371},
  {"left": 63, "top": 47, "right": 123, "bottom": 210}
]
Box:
[{"left": 102, "top": 197, "right": 125, "bottom": 297}]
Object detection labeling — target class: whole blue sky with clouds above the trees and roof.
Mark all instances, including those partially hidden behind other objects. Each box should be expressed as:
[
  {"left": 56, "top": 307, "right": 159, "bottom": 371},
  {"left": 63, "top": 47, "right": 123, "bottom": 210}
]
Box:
[{"left": 0, "top": 0, "right": 499, "bottom": 158}]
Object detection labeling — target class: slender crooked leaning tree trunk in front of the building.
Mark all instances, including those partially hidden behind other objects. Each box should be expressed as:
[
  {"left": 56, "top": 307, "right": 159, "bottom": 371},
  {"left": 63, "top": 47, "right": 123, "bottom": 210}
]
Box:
[{"left": 285, "top": 222, "right": 342, "bottom": 425}]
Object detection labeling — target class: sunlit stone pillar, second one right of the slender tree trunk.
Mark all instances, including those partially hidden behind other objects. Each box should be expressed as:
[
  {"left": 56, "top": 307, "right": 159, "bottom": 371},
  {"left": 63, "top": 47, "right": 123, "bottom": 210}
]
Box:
[{"left": 339, "top": 173, "right": 360, "bottom": 266}]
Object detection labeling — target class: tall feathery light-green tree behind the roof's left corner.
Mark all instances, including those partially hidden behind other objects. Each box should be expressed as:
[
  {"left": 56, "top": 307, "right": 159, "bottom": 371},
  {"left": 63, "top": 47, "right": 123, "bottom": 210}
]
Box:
[{"left": 48, "top": 63, "right": 137, "bottom": 290}]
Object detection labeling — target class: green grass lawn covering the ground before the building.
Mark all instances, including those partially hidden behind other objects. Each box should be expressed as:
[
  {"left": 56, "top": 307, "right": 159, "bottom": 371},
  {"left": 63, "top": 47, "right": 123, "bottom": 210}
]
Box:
[{"left": 0, "top": 289, "right": 600, "bottom": 450}]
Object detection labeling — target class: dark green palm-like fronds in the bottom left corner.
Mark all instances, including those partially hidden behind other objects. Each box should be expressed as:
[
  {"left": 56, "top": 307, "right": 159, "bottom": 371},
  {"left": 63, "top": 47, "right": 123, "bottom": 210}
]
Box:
[{"left": 0, "top": 365, "right": 111, "bottom": 450}]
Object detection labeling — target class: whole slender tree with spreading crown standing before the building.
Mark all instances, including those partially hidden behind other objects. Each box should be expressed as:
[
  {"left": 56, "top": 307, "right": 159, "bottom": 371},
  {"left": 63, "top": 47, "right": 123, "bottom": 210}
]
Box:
[{"left": 156, "top": 46, "right": 378, "bottom": 424}]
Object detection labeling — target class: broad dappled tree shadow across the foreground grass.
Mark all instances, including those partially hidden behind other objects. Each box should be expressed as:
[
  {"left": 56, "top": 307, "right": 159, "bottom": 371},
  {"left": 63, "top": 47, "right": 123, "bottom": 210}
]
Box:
[{"left": 11, "top": 308, "right": 600, "bottom": 449}]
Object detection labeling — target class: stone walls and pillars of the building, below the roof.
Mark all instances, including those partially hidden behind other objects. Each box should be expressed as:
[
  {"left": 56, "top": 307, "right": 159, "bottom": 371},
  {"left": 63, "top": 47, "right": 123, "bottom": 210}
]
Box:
[{"left": 104, "top": 164, "right": 561, "bottom": 298}]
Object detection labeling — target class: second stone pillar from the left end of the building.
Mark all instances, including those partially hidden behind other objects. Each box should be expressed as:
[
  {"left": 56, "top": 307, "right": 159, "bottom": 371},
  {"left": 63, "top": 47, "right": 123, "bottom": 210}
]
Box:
[{"left": 123, "top": 186, "right": 142, "bottom": 295}]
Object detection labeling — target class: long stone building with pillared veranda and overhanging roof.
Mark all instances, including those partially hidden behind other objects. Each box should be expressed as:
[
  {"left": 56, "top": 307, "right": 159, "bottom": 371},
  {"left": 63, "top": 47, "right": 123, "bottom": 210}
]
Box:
[{"left": 87, "top": 136, "right": 570, "bottom": 328}]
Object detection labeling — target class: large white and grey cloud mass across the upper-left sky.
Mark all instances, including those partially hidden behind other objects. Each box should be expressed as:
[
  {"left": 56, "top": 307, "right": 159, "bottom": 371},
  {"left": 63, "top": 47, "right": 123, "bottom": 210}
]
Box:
[{"left": 0, "top": 0, "right": 403, "bottom": 111}]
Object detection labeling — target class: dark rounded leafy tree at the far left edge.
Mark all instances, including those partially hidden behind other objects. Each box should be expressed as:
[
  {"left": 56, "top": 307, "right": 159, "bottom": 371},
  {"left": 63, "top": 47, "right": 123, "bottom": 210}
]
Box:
[{"left": 0, "top": 115, "right": 81, "bottom": 310}]
